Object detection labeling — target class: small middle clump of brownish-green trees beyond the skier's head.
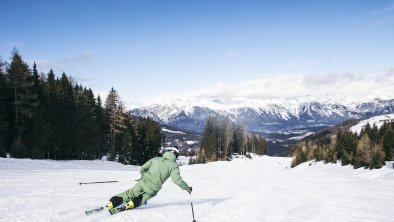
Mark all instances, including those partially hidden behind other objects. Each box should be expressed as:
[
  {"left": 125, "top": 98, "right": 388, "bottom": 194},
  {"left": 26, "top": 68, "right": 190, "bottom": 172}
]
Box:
[{"left": 190, "top": 116, "right": 267, "bottom": 164}]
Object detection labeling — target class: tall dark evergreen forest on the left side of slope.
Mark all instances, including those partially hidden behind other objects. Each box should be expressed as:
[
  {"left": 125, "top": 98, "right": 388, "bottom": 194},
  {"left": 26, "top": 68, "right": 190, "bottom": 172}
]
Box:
[{"left": 0, "top": 50, "right": 162, "bottom": 164}]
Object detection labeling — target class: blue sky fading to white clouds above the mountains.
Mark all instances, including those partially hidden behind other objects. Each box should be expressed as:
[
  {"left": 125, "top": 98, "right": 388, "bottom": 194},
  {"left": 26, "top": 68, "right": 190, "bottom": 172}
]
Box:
[{"left": 0, "top": 0, "right": 394, "bottom": 106}]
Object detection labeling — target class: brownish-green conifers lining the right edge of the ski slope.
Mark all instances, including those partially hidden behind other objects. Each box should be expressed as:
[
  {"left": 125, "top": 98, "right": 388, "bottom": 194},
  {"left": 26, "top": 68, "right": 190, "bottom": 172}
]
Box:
[{"left": 291, "top": 121, "right": 394, "bottom": 169}]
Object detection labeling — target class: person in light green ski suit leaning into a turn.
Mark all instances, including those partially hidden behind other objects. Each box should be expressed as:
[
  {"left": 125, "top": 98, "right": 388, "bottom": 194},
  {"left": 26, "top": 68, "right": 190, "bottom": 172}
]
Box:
[{"left": 107, "top": 147, "right": 192, "bottom": 214}]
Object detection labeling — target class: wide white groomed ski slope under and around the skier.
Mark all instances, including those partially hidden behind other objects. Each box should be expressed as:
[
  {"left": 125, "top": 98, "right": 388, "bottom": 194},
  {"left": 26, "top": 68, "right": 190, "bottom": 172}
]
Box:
[{"left": 0, "top": 156, "right": 394, "bottom": 222}]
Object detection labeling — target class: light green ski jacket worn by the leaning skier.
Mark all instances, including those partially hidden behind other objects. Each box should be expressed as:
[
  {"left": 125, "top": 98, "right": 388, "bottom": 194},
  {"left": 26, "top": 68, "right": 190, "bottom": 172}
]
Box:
[{"left": 140, "top": 151, "right": 189, "bottom": 192}]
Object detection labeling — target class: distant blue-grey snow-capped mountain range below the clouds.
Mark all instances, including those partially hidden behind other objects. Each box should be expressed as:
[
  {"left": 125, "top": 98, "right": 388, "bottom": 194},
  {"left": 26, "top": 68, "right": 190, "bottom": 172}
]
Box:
[{"left": 130, "top": 96, "right": 394, "bottom": 134}]
